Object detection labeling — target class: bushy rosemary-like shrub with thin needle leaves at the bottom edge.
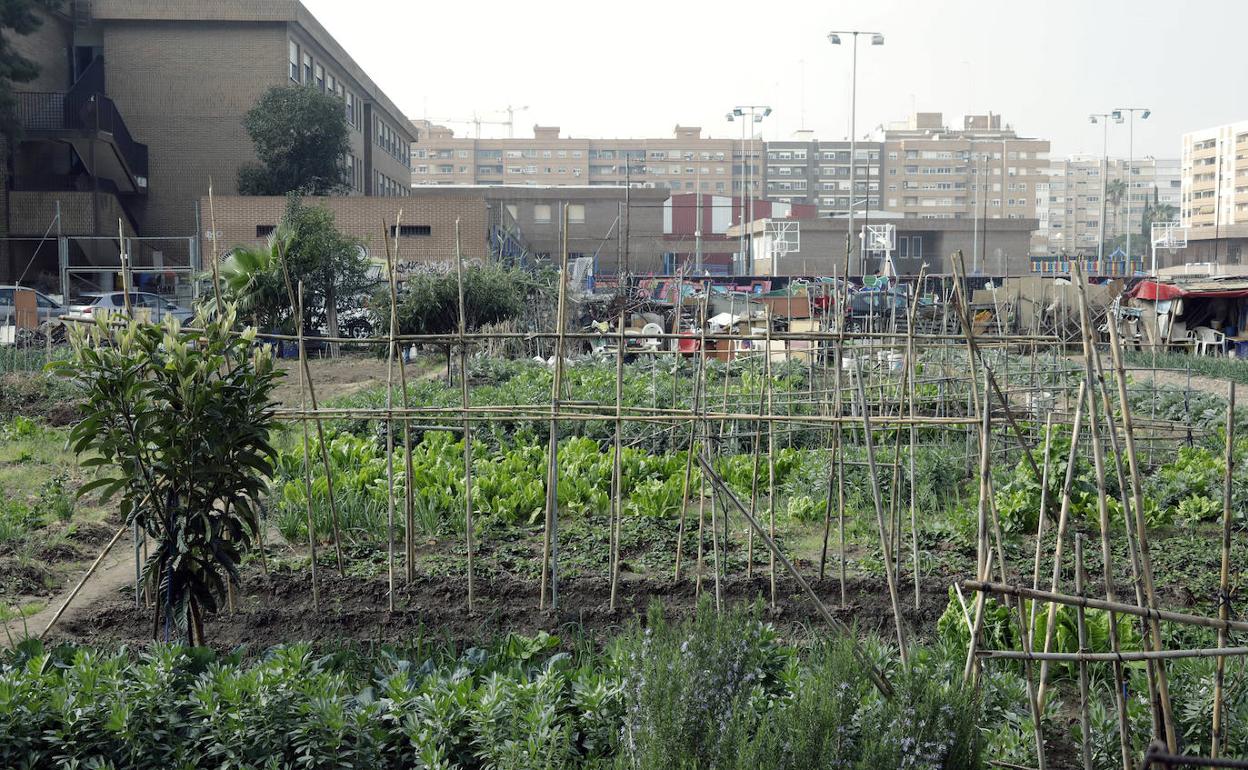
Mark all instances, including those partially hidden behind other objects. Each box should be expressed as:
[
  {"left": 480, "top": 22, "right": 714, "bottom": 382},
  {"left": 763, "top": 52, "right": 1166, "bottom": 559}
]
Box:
[{"left": 617, "top": 603, "right": 986, "bottom": 770}]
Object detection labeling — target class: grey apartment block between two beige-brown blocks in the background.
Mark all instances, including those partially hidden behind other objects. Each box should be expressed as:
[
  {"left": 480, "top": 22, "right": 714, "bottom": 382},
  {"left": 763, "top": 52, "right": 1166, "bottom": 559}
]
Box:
[{"left": 764, "top": 131, "right": 884, "bottom": 217}]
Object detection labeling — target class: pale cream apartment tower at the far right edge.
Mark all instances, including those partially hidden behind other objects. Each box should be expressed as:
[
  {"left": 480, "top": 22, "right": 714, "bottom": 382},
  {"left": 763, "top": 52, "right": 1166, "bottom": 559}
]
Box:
[{"left": 1179, "top": 121, "right": 1248, "bottom": 230}]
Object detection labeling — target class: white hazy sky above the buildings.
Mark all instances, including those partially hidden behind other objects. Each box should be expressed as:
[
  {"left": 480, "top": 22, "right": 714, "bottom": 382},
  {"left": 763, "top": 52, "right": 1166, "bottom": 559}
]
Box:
[{"left": 303, "top": 0, "right": 1248, "bottom": 157}]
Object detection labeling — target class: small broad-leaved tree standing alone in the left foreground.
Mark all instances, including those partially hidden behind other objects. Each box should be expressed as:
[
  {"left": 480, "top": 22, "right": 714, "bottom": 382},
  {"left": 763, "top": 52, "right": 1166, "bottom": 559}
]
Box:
[{"left": 50, "top": 307, "right": 278, "bottom": 644}]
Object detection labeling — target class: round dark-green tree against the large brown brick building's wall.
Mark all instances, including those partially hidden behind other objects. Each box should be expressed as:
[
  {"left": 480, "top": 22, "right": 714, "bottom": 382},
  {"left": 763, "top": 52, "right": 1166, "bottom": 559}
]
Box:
[{"left": 238, "top": 86, "right": 349, "bottom": 195}]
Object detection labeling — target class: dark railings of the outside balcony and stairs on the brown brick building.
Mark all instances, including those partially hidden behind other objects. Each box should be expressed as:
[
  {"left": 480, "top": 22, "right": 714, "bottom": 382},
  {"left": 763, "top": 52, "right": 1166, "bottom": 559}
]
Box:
[{"left": 16, "top": 59, "right": 147, "bottom": 195}]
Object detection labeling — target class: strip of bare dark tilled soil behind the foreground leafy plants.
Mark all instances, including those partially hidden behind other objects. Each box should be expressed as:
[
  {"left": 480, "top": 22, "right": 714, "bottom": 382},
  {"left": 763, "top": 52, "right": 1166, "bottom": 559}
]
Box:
[{"left": 50, "top": 566, "right": 947, "bottom": 648}]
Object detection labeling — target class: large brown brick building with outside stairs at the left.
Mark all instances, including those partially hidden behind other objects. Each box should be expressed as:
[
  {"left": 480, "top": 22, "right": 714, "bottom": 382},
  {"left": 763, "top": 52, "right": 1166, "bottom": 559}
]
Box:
[{"left": 5, "top": 0, "right": 413, "bottom": 291}]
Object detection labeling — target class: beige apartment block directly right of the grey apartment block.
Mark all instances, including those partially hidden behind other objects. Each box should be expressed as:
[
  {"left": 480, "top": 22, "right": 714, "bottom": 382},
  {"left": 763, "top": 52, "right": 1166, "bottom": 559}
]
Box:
[{"left": 884, "top": 112, "right": 1050, "bottom": 250}]
